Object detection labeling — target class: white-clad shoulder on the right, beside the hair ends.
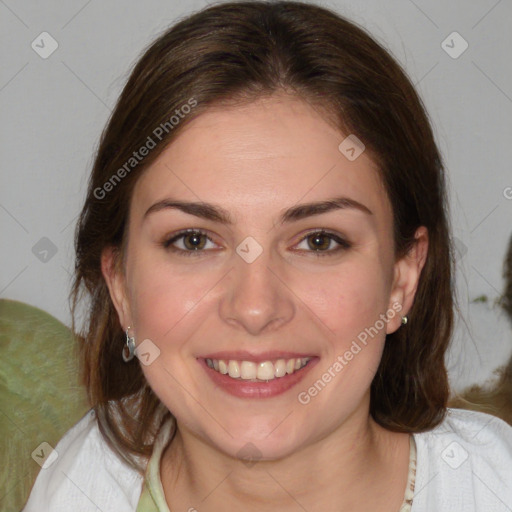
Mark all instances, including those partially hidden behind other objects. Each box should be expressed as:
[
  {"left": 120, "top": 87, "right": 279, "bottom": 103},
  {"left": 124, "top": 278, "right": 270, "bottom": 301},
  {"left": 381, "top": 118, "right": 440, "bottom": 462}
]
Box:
[{"left": 412, "top": 409, "right": 512, "bottom": 512}]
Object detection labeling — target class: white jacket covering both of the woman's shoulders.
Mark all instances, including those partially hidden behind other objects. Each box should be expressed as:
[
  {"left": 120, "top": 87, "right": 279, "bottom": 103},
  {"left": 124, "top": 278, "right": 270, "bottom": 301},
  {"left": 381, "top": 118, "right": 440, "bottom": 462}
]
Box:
[{"left": 23, "top": 409, "right": 512, "bottom": 512}]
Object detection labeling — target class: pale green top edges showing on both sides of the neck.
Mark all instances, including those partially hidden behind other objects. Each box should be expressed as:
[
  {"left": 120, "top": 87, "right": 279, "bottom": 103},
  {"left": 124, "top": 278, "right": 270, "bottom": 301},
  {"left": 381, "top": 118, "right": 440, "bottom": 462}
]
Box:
[{"left": 136, "top": 421, "right": 416, "bottom": 512}]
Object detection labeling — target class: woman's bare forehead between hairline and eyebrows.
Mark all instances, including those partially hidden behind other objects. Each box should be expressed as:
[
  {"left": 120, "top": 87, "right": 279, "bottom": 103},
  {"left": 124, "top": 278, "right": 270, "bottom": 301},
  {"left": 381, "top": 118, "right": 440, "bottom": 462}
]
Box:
[{"left": 132, "top": 96, "right": 391, "bottom": 228}]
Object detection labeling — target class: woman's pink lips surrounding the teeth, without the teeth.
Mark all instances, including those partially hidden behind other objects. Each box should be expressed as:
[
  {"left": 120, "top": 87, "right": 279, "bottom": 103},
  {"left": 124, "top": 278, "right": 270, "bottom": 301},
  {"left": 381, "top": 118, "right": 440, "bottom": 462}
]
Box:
[{"left": 197, "top": 352, "right": 320, "bottom": 398}]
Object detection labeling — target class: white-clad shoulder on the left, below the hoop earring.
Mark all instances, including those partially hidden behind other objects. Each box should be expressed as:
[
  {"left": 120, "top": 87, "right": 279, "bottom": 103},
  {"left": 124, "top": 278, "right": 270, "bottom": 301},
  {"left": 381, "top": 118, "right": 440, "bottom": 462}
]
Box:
[{"left": 23, "top": 410, "right": 143, "bottom": 512}]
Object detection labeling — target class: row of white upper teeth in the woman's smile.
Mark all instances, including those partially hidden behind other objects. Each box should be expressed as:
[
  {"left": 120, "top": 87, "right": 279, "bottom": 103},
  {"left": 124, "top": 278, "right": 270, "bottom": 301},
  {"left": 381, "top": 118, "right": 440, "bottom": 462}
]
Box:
[{"left": 206, "top": 357, "right": 311, "bottom": 380}]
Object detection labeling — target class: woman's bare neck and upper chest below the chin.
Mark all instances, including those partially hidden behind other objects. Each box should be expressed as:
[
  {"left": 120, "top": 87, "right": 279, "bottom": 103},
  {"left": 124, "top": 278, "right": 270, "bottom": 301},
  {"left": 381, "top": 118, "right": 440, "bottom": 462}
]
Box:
[{"left": 161, "top": 402, "right": 409, "bottom": 512}]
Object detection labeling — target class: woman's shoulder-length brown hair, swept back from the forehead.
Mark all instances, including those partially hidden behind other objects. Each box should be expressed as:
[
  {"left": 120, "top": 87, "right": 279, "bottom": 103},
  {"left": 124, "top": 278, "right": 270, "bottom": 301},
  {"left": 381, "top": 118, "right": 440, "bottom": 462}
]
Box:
[{"left": 71, "top": 1, "right": 454, "bottom": 471}]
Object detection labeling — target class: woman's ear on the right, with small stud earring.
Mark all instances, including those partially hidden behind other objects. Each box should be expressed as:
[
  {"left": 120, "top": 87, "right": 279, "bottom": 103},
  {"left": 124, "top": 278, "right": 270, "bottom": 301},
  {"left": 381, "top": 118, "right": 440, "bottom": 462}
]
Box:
[{"left": 386, "top": 226, "right": 428, "bottom": 334}]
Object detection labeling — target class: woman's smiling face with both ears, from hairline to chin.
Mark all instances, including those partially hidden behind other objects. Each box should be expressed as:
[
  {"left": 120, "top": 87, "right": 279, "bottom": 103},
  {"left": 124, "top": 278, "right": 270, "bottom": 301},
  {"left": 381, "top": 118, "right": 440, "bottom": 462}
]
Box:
[{"left": 103, "top": 96, "right": 426, "bottom": 459}]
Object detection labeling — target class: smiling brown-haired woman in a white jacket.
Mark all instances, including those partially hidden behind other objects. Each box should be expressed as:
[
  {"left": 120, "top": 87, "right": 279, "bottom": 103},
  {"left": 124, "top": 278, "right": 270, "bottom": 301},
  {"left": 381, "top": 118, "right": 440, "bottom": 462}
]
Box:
[{"left": 25, "top": 2, "right": 512, "bottom": 512}]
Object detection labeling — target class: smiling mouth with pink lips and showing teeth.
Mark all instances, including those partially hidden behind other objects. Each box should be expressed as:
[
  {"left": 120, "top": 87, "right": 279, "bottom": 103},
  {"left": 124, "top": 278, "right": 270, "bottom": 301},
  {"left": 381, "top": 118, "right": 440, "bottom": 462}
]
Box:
[{"left": 197, "top": 354, "right": 319, "bottom": 398}]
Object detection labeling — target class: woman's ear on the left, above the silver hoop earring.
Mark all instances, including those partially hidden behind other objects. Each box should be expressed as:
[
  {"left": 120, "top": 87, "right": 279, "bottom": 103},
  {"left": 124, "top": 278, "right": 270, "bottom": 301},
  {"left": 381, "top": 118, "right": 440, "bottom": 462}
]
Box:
[{"left": 101, "top": 247, "right": 132, "bottom": 330}]
